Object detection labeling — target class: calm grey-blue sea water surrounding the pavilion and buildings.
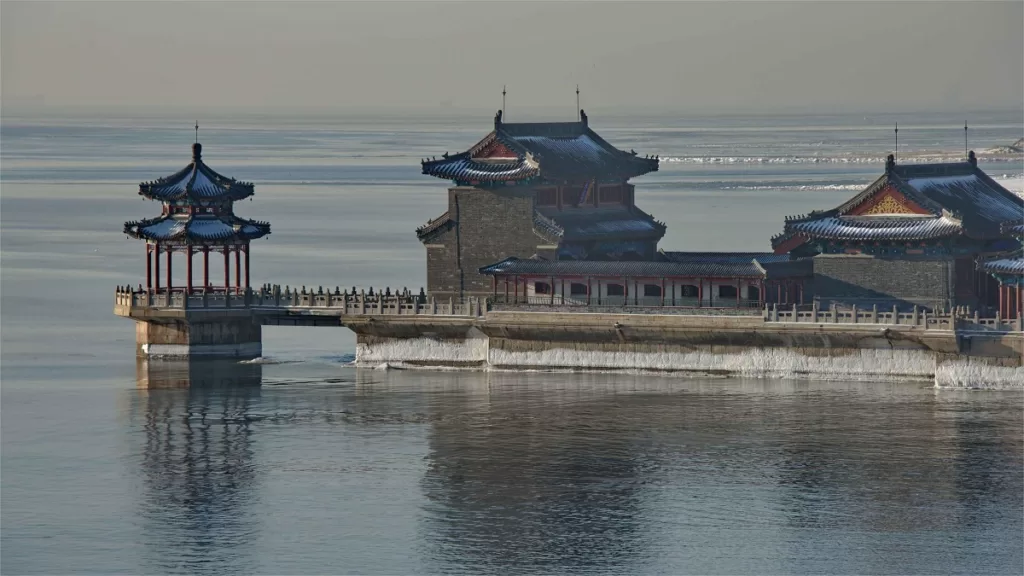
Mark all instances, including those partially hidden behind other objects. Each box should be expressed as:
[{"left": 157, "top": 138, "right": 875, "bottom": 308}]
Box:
[{"left": 0, "top": 113, "right": 1024, "bottom": 574}]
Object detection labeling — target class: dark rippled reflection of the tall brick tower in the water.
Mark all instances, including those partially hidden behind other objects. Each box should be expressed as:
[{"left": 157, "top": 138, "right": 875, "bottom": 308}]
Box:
[{"left": 405, "top": 374, "right": 651, "bottom": 572}]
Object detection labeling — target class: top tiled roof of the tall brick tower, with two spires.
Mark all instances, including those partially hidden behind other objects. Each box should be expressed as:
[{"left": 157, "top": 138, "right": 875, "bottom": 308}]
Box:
[{"left": 422, "top": 111, "right": 658, "bottom": 186}]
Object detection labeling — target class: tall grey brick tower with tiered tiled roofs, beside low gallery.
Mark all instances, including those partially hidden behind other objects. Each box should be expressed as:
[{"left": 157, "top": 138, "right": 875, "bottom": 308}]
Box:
[{"left": 416, "top": 110, "right": 666, "bottom": 298}]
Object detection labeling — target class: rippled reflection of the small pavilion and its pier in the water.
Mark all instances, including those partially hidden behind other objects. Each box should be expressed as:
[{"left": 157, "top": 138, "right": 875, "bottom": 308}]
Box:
[{"left": 132, "top": 361, "right": 261, "bottom": 573}]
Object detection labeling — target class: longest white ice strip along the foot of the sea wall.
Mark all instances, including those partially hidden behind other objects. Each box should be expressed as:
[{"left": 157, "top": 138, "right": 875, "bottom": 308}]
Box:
[{"left": 487, "top": 348, "right": 935, "bottom": 380}]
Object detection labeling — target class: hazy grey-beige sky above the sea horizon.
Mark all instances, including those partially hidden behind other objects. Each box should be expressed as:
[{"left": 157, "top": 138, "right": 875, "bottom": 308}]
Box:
[{"left": 0, "top": 0, "right": 1024, "bottom": 111}]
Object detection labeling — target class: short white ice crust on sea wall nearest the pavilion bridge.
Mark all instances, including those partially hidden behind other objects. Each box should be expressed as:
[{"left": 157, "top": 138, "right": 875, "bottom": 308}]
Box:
[{"left": 355, "top": 338, "right": 487, "bottom": 366}]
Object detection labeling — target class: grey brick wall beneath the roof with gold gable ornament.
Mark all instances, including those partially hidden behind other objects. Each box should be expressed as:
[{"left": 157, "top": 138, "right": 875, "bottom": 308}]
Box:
[{"left": 813, "top": 254, "right": 956, "bottom": 308}]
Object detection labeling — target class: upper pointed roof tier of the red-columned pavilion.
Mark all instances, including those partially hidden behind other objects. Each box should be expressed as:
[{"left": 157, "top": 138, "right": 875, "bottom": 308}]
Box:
[{"left": 138, "top": 142, "right": 253, "bottom": 202}]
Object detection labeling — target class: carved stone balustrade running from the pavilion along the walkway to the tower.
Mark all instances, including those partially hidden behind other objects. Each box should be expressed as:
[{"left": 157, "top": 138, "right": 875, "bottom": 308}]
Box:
[{"left": 115, "top": 285, "right": 486, "bottom": 317}]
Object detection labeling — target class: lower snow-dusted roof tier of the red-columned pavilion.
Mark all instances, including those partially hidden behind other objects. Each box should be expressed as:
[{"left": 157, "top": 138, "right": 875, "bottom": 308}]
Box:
[{"left": 125, "top": 214, "right": 270, "bottom": 244}]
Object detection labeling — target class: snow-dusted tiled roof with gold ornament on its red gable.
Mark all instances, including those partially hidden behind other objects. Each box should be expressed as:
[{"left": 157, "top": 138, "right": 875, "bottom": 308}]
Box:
[{"left": 772, "top": 152, "right": 1024, "bottom": 252}]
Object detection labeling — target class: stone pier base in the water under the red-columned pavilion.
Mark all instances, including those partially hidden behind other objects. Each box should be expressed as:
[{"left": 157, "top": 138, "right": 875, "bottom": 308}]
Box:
[{"left": 135, "top": 314, "right": 263, "bottom": 359}]
